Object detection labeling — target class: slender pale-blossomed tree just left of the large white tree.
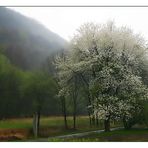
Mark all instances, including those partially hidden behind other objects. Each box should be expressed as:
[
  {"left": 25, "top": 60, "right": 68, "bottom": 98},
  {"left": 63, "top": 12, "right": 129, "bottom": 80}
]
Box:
[{"left": 55, "top": 56, "right": 79, "bottom": 129}]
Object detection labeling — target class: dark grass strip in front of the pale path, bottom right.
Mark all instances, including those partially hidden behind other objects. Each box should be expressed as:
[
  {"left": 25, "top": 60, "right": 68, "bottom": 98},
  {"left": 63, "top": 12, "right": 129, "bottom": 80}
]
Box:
[{"left": 49, "top": 129, "right": 148, "bottom": 142}]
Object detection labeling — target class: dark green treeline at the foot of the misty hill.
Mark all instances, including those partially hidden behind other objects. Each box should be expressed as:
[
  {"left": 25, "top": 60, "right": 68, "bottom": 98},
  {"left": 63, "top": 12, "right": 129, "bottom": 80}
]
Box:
[{"left": 0, "top": 49, "right": 86, "bottom": 119}]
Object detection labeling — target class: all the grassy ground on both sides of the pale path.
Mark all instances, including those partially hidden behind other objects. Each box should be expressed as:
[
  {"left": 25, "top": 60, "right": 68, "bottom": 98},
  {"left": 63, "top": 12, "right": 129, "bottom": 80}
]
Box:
[{"left": 0, "top": 116, "right": 148, "bottom": 142}]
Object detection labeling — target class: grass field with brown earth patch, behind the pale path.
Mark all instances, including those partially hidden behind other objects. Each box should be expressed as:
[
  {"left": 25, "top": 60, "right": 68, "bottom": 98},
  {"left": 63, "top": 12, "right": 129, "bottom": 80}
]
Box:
[{"left": 0, "top": 116, "right": 118, "bottom": 141}]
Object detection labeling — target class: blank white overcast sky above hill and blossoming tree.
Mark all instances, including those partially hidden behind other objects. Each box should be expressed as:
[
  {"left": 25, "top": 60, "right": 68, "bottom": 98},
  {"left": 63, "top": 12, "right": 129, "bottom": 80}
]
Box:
[{"left": 7, "top": 7, "right": 148, "bottom": 41}]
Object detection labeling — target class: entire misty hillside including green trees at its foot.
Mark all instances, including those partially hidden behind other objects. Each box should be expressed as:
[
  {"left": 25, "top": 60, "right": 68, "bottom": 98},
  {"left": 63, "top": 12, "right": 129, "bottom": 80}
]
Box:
[{"left": 0, "top": 7, "right": 67, "bottom": 119}]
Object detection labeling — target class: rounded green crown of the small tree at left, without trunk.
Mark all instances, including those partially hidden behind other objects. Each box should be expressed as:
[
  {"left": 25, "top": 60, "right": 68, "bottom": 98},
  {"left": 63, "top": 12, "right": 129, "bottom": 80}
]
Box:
[{"left": 24, "top": 72, "right": 57, "bottom": 111}]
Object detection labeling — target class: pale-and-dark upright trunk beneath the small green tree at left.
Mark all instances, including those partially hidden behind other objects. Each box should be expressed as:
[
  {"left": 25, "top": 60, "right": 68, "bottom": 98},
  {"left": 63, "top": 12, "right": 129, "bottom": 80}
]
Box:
[{"left": 33, "top": 111, "right": 40, "bottom": 138}]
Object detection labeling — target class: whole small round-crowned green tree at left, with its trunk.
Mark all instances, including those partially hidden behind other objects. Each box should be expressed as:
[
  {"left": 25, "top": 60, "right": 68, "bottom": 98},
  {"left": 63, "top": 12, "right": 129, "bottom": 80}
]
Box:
[{"left": 25, "top": 73, "right": 57, "bottom": 137}]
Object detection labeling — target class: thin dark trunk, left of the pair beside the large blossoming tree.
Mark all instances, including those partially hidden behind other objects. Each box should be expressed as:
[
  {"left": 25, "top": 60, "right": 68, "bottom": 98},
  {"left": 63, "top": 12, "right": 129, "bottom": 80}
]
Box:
[{"left": 61, "top": 97, "right": 68, "bottom": 129}]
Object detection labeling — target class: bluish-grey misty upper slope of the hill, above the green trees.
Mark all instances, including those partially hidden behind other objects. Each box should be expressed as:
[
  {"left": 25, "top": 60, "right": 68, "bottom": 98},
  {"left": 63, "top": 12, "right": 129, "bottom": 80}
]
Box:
[{"left": 0, "top": 7, "right": 67, "bottom": 70}]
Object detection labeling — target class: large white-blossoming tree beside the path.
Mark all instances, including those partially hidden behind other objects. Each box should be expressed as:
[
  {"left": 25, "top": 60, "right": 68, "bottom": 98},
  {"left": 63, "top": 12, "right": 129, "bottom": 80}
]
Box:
[{"left": 55, "top": 22, "right": 147, "bottom": 131}]
